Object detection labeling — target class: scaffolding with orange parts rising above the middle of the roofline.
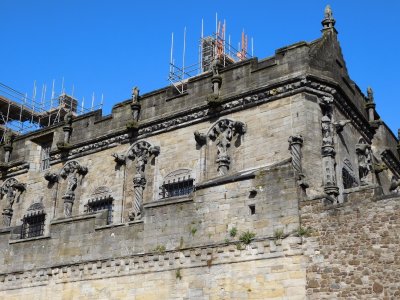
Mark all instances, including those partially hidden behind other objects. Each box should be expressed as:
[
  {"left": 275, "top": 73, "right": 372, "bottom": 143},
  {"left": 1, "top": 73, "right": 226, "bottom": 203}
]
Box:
[{"left": 168, "top": 22, "right": 252, "bottom": 94}]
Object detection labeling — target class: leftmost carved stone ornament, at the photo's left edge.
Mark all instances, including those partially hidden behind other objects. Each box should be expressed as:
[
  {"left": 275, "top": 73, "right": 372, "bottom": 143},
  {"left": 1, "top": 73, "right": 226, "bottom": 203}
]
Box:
[{"left": 0, "top": 178, "right": 26, "bottom": 227}]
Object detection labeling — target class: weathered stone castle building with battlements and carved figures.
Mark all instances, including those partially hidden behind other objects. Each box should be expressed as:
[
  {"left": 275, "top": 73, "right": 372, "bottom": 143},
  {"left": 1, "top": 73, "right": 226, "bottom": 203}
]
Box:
[{"left": 0, "top": 7, "right": 400, "bottom": 300}]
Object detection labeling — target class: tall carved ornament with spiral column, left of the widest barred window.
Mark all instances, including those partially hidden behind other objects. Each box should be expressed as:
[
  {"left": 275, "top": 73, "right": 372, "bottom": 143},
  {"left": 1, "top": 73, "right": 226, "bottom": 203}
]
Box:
[{"left": 126, "top": 141, "right": 160, "bottom": 221}]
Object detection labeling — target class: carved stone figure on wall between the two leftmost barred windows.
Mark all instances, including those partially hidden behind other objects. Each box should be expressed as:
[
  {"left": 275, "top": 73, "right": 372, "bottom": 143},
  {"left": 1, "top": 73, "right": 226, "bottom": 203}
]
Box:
[{"left": 60, "top": 161, "right": 88, "bottom": 217}]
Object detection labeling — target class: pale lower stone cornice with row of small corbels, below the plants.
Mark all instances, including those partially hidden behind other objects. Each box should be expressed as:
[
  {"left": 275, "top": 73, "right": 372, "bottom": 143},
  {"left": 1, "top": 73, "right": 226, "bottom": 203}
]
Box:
[{"left": 0, "top": 236, "right": 303, "bottom": 290}]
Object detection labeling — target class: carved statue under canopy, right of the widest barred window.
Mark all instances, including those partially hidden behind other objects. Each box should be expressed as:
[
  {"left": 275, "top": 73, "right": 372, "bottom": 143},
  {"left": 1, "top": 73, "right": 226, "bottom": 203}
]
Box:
[{"left": 208, "top": 119, "right": 246, "bottom": 175}]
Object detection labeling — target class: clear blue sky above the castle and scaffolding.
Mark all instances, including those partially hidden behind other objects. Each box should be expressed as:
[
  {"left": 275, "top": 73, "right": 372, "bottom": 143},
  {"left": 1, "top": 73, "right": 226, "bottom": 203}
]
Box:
[{"left": 0, "top": 0, "right": 400, "bottom": 133}]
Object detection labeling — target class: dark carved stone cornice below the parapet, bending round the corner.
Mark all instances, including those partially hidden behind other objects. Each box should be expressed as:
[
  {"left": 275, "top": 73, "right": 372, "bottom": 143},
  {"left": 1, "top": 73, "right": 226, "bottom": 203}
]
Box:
[{"left": 46, "top": 75, "right": 374, "bottom": 164}]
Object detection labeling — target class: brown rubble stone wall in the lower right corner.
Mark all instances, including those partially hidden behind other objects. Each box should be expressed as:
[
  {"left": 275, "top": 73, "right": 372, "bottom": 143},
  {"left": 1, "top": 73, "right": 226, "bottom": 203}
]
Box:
[{"left": 301, "top": 188, "right": 400, "bottom": 299}]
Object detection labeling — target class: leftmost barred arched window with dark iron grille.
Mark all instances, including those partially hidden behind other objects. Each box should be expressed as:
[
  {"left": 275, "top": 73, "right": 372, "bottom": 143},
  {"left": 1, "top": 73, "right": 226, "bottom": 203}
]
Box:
[{"left": 21, "top": 202, "right": 46, "bottom": 239}]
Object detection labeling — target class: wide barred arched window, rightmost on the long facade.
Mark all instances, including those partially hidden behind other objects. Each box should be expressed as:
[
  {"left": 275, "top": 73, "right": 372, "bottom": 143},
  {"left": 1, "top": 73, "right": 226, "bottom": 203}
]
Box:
[{"left": 160, "top": 169, "right": 194, "bottom": 199}]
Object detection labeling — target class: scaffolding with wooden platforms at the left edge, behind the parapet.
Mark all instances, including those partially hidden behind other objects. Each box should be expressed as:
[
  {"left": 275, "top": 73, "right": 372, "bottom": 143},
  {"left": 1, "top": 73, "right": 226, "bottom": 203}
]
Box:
[{"left": 0, "top": 83, "right": 103, "bottom": 142}]
